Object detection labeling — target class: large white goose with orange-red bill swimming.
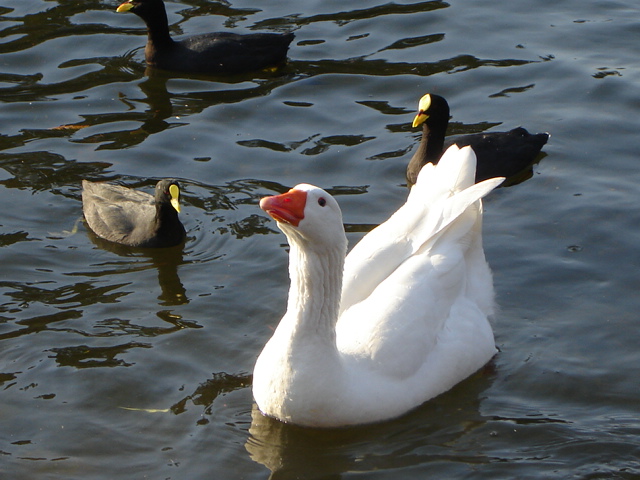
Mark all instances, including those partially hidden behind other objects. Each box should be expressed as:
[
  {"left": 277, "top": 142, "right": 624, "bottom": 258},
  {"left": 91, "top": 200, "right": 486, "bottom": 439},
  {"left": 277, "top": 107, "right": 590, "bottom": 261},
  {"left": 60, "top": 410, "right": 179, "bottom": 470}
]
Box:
[{"left": 253, "top": 145, "right": 504, "bottom": 427}]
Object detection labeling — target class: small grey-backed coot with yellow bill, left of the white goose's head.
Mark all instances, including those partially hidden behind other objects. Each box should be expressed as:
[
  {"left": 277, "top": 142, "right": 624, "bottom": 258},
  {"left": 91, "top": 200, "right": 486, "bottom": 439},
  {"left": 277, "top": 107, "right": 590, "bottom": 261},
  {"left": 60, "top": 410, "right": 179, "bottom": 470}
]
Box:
[{"left": 82, "top": 179, "right": 186, "bottom": 247}]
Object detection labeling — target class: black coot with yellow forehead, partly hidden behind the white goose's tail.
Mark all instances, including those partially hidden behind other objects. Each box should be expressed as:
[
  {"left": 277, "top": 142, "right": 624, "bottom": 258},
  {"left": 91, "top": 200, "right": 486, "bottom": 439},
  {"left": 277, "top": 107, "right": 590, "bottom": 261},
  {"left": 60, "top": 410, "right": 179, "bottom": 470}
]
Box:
[{"left": 407, "top": 93, "right": 549, "bottom": 187}]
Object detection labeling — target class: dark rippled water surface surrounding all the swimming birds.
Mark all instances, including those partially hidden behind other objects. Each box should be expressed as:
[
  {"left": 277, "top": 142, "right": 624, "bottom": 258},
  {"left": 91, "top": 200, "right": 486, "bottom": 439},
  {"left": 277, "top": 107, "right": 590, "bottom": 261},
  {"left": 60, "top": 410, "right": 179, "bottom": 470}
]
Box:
[{"left": 0, "top": 0, "right": 640, "bottom": 480}]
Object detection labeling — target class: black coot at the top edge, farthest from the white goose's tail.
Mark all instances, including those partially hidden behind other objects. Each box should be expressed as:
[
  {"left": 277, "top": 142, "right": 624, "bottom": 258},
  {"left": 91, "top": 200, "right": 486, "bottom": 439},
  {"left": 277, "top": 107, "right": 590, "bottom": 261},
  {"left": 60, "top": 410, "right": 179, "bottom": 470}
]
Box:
[{"left": 116, "top": 0, "right": 294, "bottom": 75}]
